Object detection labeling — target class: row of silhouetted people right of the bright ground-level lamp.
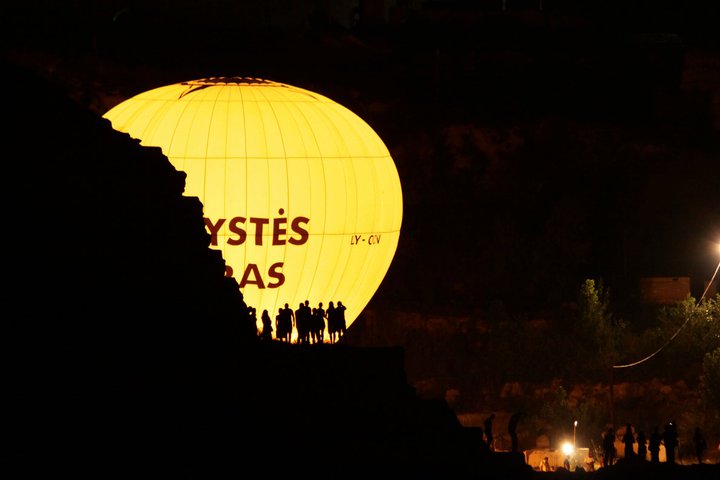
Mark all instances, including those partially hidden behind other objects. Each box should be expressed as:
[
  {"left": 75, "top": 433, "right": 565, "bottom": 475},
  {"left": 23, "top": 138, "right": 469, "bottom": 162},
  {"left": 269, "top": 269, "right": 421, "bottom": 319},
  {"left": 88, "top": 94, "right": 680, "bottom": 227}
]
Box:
[{"left": 602, "top": 422, "right": 707, "bottom": 467}]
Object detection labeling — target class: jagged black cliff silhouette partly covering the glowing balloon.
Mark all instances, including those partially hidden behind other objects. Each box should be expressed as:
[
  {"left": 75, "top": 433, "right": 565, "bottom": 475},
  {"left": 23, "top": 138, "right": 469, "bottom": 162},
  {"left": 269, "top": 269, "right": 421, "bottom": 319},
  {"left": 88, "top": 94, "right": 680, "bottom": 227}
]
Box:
[{"left": 0, "top": 58, "right": 500, "bottom": 476}]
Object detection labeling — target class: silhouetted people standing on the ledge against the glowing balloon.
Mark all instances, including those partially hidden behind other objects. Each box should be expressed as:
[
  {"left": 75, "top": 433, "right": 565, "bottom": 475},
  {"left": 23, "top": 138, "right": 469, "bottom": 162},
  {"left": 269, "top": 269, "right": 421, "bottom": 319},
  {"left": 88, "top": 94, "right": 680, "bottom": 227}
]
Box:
[{"left": 249, "top": 300, "right": 347, "bottom": 345}]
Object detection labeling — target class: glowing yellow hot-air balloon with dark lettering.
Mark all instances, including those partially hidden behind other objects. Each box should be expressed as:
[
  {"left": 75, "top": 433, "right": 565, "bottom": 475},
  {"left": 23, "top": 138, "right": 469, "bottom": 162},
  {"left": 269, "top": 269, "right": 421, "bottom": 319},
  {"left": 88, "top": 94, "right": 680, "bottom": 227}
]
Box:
[{"left": 104, "top": 77, "right": 402, "bottom": 334}]
